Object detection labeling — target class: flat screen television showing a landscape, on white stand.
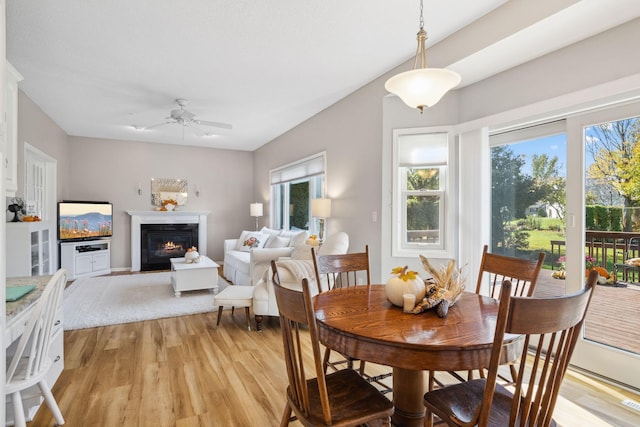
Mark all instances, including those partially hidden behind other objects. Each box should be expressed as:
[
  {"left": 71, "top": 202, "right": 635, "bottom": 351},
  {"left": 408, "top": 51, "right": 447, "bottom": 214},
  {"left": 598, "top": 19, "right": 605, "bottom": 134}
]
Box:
[{"left": 58, "top": 200, "right": 113, "bottom": 242}]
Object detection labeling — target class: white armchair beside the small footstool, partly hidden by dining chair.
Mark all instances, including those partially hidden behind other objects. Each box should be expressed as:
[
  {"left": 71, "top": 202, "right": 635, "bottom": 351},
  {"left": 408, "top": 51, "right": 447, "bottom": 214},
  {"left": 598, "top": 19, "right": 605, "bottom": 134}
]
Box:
[{"left": 253, "top": 232, "right": 349, "bottom": 331}]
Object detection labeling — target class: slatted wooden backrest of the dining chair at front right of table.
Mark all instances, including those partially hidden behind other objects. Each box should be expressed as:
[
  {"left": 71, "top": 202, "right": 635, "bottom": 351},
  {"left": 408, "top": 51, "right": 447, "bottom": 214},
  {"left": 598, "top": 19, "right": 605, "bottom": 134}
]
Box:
[{"left": 478, "top": 272, "right": 598, "bottom": 427}]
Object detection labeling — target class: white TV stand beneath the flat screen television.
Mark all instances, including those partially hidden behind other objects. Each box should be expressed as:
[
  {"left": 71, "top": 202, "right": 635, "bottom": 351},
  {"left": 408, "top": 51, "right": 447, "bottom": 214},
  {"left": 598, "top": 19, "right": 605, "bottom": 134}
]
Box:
[{"left": 60, "top": 239, "right": 111, "bottom": 280}]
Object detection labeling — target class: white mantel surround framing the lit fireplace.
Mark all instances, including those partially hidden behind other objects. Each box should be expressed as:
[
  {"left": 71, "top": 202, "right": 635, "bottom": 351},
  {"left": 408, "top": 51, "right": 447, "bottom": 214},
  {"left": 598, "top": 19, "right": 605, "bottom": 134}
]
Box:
[{"left": 127, "top": 211, "right": 210, "bottom": 271}]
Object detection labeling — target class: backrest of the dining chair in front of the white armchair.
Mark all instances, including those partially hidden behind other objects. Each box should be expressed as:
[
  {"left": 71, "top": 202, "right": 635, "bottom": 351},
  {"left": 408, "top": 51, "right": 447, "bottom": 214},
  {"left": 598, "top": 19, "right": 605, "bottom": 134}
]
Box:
[{"left": 311, "top": 245, "right": 371, "bottom": 292}]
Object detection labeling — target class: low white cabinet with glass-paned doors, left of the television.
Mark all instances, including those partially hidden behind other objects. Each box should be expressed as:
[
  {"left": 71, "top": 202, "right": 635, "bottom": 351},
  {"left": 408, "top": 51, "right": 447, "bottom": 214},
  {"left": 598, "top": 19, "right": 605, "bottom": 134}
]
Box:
[{"left": 6, "top": 221, "right": 53, "bottom": 277}]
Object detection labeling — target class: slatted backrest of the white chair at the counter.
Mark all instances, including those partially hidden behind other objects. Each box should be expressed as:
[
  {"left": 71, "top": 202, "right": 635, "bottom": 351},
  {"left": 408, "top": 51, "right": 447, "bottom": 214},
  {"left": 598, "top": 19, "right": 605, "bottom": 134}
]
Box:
[{"left": 6, "top": 269, "right": 67, "bottom": 383}]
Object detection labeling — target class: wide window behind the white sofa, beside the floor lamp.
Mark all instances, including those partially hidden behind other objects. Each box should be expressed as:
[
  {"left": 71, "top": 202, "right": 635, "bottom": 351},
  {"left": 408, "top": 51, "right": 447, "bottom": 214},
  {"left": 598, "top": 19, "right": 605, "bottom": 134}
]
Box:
[{"left": 271, "top": 152, "right": 326, "bottom": 232}]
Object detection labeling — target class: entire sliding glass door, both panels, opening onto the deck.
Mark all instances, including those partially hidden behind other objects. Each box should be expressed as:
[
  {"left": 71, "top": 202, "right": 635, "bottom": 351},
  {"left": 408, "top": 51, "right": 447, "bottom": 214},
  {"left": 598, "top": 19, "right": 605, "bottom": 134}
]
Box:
[{"left": 490, "top": 108, "right": 640, "bottom": 388}]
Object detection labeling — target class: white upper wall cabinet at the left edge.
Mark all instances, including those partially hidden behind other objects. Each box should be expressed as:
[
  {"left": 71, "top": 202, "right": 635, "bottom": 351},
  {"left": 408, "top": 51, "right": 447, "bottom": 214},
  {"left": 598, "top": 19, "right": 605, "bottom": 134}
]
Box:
[{"left": 4, "top": 61, "right": 22, "bottom": 196}]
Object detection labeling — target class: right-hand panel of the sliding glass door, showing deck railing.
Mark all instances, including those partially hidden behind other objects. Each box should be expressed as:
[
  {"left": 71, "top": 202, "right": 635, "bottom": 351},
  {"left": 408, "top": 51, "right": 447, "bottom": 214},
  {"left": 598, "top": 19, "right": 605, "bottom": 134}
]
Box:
[{"left": 567, "top": 104, "right": 640, "bottom": 388}]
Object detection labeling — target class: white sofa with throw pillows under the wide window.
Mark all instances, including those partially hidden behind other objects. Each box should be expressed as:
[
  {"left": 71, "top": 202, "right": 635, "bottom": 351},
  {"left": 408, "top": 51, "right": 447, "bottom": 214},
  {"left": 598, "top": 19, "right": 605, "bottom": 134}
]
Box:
[{"left": 223, "top": 227, "right": 308, "bottom": 286}]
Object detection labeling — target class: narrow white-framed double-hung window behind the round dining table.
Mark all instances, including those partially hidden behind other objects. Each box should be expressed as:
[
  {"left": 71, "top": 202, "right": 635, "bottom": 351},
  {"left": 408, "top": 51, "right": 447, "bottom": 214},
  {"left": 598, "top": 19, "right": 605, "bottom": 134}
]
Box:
[{"left": 392, "top": 129, "right": 455, "bottom": 256}]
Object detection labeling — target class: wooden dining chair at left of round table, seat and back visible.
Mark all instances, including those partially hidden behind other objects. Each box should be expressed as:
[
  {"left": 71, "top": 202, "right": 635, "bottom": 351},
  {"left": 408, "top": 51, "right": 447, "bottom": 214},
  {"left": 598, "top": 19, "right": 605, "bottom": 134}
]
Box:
[{"left": 272, "top": 261, "right": 393, "bottom": 427}]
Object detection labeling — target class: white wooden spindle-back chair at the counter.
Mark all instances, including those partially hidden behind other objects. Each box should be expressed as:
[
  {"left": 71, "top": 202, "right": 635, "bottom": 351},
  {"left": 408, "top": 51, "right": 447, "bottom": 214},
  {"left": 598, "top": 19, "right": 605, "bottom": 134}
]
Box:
[{"left": 5, "top": 268, "right": 67, "bottom": 427}]
